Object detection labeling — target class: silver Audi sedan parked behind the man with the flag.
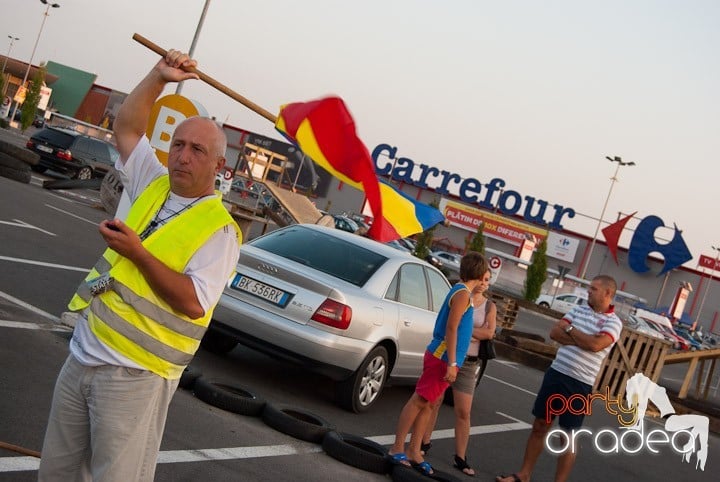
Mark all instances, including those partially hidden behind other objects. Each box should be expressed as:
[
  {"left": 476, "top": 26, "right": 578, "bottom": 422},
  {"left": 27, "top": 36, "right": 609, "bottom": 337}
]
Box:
[{"left": 202, "top": 224, "right": 450, "bottom": 413}]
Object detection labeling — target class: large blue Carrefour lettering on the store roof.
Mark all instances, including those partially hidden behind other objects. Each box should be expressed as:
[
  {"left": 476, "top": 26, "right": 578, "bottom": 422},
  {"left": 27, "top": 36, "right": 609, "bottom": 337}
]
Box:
[{"left": 372, "top": 144, "right": 575, "bottom": 229}]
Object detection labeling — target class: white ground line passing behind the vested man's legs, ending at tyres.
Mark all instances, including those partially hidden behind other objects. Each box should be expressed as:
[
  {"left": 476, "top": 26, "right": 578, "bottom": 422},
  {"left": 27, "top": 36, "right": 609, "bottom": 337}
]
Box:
[{"left": 0, "top": 442, "right": 322, "bottom": 473}]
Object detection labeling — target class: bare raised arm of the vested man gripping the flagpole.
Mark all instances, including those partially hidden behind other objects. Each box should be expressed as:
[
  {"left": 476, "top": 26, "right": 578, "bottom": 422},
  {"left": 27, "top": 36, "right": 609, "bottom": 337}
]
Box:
[{"left": 113, "top": 50, "right": 198, "bottom": 162}]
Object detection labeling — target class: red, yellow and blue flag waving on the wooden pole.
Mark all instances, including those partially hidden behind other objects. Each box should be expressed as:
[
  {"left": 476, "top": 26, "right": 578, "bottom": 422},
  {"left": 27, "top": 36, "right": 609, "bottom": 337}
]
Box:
[{"left": 275, "top": 97, "right": 444, "bottom": 243}]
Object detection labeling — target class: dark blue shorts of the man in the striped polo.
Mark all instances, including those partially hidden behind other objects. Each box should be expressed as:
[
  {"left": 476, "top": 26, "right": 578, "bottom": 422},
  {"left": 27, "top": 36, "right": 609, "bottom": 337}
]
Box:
[{"left": 532, "top": 368, "right": 592, "bottom": 430}]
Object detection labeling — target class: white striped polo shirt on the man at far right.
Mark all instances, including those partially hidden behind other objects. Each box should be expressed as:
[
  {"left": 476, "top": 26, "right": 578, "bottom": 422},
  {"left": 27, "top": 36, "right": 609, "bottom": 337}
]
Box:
[{"left": 552, "top": 305, "right": 623, "bottom": 386}]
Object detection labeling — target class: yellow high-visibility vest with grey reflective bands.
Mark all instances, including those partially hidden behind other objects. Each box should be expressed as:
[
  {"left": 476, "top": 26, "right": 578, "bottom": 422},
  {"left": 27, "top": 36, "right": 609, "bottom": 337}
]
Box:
[{"left": 68, "top": 175, "right": 242, "bottom": 380}]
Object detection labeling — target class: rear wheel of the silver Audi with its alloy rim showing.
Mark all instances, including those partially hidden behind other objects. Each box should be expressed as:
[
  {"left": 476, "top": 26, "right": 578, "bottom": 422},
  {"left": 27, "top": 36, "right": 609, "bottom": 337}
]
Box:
[{"left": 335, "top": 346, "right": 390, "bottom": 413}]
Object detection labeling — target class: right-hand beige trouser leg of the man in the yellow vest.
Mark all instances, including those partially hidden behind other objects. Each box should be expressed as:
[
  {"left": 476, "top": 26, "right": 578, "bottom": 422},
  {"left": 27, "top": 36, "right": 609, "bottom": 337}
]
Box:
[{"left": 88, "top": 366, "right": 178, "bottom": 482}]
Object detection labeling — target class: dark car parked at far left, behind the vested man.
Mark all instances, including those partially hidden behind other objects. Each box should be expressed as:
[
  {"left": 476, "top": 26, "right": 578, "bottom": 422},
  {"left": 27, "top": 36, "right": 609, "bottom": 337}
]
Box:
[{"left": 27, "top": 127, "right": 120, "bottom": 179}]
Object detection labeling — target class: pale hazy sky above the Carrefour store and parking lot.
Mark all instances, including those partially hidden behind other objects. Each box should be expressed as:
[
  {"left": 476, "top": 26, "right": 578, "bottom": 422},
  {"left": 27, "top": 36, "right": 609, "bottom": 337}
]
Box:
[{"left": 0, "top": 0, "right": 720, "bottom": 268}]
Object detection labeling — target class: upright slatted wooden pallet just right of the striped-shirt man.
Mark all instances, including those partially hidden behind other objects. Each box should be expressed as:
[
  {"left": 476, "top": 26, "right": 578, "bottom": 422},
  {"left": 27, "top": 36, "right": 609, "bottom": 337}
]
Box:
[{"left": 593, "top": 327, "right": 671, "bottom": 399}]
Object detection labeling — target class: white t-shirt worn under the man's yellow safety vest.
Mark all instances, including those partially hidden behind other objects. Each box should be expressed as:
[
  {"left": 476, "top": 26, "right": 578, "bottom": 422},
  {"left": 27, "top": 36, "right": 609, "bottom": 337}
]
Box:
[{"left": 70, "top": 137, "right": 240, "bottom": 369}]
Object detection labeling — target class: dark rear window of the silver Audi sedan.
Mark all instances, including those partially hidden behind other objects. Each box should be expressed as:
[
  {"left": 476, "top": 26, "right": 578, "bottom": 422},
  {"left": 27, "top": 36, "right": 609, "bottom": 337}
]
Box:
[{"left": 248, "top": 226, "right": 387, "bottom": 286}]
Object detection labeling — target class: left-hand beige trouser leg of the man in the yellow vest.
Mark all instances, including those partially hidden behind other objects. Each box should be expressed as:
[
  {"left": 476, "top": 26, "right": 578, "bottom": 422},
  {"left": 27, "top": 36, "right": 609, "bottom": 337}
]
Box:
[{"left": 38, "top": 355, "right": 92, "bottom": 482}]
